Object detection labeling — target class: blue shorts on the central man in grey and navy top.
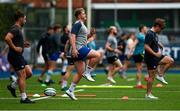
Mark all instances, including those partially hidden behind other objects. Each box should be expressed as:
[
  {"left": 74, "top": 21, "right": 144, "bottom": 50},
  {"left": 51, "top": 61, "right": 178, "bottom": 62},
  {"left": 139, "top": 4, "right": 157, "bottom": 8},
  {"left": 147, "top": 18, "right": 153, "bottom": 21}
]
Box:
[{"left": 75, "top": 46, "right": 91, "bottom": 61}]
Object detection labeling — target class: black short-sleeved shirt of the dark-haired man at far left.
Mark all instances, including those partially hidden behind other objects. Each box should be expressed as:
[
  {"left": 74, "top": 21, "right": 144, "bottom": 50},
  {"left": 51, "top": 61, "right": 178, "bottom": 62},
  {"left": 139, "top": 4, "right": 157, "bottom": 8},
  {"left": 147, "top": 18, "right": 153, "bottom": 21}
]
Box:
[{"left": 9, "top": 25, "right": 24, "bottom": 54}]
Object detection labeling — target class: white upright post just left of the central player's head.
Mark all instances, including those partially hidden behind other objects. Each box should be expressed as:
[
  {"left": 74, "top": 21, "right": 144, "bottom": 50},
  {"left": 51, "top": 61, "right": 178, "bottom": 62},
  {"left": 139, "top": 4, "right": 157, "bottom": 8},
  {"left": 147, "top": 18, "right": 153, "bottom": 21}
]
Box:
[{"left": 68, "top": 0, "right": 72, "bottom": 29}]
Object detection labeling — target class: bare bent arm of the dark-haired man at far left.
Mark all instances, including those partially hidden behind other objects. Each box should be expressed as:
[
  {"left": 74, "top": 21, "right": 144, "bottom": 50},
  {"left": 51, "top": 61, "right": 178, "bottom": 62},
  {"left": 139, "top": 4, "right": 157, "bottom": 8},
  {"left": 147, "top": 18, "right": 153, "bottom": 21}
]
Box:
[{"left": 5, "top": 33, "right": 22, "bottom": 53}]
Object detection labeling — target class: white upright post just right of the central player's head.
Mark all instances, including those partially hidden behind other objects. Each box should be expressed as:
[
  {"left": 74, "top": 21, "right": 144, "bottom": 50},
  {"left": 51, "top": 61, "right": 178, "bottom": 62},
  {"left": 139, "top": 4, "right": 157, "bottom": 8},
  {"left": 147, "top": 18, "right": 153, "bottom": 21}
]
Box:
[{"left": 87, "top": 0, "right": 91, "bottom": 29}]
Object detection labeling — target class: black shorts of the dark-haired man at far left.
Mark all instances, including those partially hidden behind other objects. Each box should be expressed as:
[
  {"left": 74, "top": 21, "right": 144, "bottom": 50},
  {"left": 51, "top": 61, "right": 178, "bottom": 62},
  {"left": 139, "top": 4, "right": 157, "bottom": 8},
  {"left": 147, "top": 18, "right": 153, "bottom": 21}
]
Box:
[{"left": 8, "top": 52, "right": 27, "bottom": 71}]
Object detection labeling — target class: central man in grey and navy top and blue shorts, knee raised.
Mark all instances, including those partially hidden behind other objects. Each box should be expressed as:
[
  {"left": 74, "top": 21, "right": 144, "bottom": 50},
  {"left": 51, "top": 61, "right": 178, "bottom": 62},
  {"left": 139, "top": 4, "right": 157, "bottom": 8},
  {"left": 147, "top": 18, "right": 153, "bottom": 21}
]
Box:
[{"left": 66, "top": 8, "right": 100, "bottom": 100}]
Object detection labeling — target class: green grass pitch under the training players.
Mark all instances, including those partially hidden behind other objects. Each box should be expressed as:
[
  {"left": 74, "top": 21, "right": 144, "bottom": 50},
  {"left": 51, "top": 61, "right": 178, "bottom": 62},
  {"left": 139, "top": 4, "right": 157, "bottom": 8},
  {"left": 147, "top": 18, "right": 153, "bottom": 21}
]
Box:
[{"left": 0, "top": 74, "right": 180, "bottom": 110}]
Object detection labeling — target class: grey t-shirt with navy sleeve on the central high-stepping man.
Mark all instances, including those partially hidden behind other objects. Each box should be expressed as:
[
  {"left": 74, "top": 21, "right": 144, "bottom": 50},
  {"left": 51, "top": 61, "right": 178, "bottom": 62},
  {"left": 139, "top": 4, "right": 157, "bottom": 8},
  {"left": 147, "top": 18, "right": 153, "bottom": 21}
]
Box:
[{"left": 71, "top": 21, "right": 88, "bottom": 50}]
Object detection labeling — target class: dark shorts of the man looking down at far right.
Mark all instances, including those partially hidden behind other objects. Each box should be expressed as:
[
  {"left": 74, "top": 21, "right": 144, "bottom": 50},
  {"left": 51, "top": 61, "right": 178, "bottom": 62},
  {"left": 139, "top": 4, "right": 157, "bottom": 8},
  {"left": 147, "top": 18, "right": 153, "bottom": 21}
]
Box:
[{"left": 145, "top": 55, "right": 165, "bottom": 70}]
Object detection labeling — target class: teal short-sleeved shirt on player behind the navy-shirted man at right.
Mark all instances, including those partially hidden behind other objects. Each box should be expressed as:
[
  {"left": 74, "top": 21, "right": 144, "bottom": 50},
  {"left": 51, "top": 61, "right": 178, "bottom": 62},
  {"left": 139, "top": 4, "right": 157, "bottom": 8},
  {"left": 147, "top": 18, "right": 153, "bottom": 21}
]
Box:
[{"left": 133, "top": 33, "right": 145, "bottom": 55}]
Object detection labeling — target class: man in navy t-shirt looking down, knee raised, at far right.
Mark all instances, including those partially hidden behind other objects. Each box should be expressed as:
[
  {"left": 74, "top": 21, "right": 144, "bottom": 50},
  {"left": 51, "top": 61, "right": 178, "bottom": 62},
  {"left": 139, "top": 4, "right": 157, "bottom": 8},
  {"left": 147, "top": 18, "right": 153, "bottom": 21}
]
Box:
[{"left": 144, "top": 18, "right": 174, "bottom": 99}]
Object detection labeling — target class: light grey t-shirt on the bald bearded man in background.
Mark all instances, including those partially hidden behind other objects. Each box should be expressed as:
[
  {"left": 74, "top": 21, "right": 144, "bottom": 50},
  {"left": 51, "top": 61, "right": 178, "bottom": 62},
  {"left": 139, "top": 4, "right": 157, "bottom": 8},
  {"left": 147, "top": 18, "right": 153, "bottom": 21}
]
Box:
[{"left": 106, "top": 36, "right": 117, "bottom": 57}]
